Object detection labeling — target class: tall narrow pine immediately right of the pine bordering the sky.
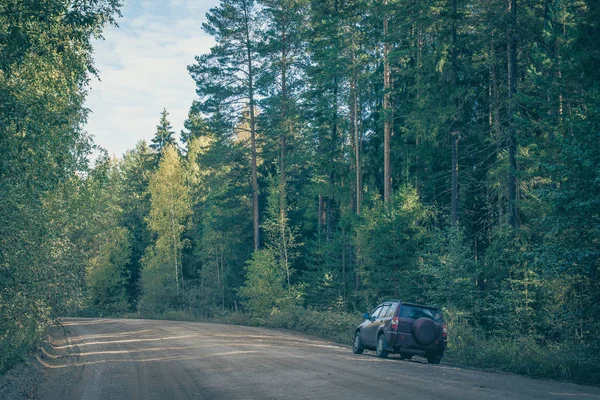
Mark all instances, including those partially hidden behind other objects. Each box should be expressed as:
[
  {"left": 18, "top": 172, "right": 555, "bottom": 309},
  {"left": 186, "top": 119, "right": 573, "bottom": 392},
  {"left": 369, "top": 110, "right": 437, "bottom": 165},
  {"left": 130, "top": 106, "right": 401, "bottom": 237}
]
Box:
[{"left": 259, "top": 0, "right": 307, "bottom": 282}]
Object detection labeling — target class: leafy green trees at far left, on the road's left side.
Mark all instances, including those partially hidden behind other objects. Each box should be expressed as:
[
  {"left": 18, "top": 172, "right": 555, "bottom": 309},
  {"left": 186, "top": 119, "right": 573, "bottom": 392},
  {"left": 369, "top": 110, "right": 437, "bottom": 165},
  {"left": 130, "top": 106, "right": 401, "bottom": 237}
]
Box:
[{"left": 0, "top": 0, "right": 120, "bottom": 373}]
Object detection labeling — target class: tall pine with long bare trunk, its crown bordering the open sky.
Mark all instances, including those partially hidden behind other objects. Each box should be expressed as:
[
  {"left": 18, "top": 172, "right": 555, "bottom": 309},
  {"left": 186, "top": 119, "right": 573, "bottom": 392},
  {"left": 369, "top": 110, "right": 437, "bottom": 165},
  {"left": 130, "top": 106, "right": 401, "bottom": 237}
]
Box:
[{"left": 188, "top": 0, "right": 261, "bottom": 250}]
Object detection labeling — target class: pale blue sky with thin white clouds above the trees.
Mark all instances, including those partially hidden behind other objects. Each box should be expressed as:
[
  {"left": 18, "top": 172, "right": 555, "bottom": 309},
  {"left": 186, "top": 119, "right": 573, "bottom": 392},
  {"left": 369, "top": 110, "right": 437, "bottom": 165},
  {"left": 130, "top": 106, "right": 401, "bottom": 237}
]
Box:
[{"left": 86, "top": 0, "right": 219, "bottom": 157}]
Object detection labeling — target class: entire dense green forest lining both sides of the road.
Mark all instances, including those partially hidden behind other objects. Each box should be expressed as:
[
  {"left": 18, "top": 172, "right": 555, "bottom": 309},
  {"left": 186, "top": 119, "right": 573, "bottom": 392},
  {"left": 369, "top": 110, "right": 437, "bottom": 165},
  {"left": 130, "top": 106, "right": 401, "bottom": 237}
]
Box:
[{"left": 0, "top": 0, "right": 600, "bottom": 383}]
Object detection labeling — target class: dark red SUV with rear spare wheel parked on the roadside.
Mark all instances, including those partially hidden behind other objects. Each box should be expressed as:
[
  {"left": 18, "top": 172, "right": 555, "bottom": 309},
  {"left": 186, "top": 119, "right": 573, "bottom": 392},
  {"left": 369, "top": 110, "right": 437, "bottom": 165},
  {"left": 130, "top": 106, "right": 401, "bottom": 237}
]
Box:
[{"left": 352, "top": 300, "right": 447, "bottom": 364}]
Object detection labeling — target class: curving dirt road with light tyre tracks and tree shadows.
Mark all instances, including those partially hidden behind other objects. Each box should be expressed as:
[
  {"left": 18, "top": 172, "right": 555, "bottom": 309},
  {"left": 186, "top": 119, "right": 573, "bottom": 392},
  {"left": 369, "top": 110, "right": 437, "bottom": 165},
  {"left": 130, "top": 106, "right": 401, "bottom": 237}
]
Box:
[{"left": 37, "top": 319, "right": 600, "bottom": 400}]
